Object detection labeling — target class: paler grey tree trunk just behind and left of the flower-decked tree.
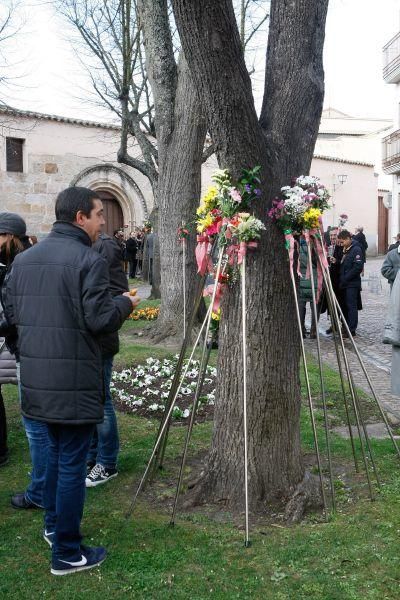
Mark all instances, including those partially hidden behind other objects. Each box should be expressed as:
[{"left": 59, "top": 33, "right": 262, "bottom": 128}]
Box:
[{"left": 154, "top": 55, "right": 206, "bottom": 343}]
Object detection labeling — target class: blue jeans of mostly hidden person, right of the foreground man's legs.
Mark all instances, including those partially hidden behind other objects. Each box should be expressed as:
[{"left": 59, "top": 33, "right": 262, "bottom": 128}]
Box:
[{"left": 87, "top": 356, "right": 119, "bottom": 469}]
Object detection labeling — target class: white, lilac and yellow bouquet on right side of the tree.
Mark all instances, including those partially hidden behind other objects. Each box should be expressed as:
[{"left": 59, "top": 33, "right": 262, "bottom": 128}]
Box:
[{"left": 268, "top": 175, "right": 330, "bottom": 235}]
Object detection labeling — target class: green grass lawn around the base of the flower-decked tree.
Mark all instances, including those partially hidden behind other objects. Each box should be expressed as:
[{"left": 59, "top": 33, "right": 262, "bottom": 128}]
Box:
[{"left": 0, "top": 330, "right": 400, "bottom": 600}]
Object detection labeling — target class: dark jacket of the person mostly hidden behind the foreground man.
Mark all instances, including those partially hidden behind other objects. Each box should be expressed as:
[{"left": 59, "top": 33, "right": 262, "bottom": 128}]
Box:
[{"left": 92, "top": 233, "right": 129, "bottom": 357}]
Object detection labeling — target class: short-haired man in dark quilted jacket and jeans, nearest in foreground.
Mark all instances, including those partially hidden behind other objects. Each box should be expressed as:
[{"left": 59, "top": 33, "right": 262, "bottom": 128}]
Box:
[{"left": 5, "top": 188, "right": 138, "bottom": 575}]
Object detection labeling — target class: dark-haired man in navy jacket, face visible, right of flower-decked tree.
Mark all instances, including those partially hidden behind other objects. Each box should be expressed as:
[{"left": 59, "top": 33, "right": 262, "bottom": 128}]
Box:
[{"left": 338, "top": 229, "right": 364, "bottom": 336}]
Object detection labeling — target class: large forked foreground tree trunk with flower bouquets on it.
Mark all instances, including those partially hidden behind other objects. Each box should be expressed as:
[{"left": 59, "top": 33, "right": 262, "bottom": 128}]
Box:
[{"left": 173, "top": 0, "right": 328, "bottom": 510}]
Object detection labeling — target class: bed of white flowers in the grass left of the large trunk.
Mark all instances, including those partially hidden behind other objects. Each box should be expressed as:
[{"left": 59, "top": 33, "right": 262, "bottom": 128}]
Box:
[{"left": 111, "top": 355, "right": 217, "bottom": 421}]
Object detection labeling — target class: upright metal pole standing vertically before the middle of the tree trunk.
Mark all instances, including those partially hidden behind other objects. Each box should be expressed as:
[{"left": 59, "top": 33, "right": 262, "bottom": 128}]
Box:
[{"left": 241, "top": 255, "right": 251, "bottom": 548}]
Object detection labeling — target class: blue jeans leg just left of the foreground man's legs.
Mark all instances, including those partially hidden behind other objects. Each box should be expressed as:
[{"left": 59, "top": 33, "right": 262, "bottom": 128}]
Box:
[{"left": 17, "top": 362, "right": 49, "bottom": 508}]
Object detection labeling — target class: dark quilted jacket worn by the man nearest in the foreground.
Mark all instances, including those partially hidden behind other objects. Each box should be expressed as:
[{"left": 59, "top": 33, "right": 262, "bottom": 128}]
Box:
[{"left": 5, "top": 222, "right": 132, "bottom": 424}]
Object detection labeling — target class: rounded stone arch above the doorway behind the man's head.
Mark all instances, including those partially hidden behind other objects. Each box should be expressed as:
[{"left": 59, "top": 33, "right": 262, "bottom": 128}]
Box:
[{"left": 70, "top": 163, "right": 149, "bottom": 227}]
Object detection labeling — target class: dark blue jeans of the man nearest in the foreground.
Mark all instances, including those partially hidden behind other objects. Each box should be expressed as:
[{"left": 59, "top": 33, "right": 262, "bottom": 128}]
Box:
[{"left": 44, "top": 423, "right": 95, "bottom": 560}]
